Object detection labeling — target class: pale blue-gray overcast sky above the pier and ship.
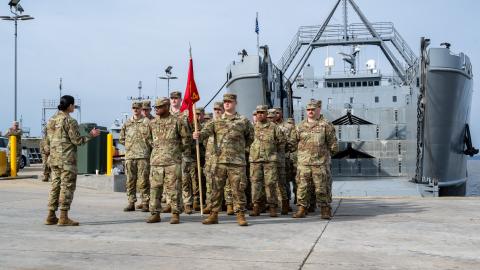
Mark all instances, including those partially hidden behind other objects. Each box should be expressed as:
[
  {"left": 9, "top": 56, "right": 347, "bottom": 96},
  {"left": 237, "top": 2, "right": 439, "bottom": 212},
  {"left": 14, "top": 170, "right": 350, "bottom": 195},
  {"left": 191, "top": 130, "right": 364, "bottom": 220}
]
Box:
[{"left": 0, "top": 0, "right": 480, "bottom": 141}]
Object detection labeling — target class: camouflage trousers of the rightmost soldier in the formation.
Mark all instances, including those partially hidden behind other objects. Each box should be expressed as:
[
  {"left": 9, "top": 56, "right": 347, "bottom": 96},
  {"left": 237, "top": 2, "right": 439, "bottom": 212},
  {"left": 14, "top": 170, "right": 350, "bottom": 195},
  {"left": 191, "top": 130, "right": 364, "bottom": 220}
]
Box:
[{"left": 297, "top": 165, "right": 332, "bottom": 207}]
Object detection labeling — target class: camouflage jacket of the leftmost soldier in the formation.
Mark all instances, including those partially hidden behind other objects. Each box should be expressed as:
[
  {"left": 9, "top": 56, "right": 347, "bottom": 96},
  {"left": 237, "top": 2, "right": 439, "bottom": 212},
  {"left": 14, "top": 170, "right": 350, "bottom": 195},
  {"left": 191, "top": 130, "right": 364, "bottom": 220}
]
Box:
[{"left": 118, "top": 117, "right": 151, "bottom": 159}]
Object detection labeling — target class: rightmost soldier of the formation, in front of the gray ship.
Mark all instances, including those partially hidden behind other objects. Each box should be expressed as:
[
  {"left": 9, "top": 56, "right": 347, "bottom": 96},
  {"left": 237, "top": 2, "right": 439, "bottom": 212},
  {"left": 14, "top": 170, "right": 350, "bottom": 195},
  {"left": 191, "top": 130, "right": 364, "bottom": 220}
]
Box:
[{"left": 293, "top": 101, "right": 337, "bottom": 219}]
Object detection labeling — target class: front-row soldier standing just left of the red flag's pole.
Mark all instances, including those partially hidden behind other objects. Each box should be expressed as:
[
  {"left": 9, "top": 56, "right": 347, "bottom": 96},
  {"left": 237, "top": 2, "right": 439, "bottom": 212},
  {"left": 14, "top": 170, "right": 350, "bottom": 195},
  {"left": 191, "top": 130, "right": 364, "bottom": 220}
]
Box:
[{"left": 147, "top": 98, "right": 191, "bottom": 224}]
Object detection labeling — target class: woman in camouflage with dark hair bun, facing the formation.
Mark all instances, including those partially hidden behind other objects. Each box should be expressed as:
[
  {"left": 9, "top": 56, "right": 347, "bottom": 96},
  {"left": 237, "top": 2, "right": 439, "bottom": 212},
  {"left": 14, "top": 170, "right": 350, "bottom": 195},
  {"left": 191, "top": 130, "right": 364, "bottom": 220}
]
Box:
[{"left": 45, "top": 95, "right": 100, "bottom": 226}]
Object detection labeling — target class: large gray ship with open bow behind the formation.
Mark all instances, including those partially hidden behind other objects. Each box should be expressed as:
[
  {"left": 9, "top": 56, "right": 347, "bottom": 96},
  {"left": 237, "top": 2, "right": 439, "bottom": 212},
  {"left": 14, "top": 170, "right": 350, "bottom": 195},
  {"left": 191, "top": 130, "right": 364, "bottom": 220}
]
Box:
[{"left": 226, "top": 0, "right": 478, "bottom": 196}]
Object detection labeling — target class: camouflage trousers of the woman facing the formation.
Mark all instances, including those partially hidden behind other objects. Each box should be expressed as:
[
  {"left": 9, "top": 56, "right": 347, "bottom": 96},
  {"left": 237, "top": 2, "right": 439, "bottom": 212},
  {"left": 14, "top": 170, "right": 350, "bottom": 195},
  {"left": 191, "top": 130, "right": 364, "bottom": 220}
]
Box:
[{"left": 48, "top": 166, "right": 77, "bottom": 211}]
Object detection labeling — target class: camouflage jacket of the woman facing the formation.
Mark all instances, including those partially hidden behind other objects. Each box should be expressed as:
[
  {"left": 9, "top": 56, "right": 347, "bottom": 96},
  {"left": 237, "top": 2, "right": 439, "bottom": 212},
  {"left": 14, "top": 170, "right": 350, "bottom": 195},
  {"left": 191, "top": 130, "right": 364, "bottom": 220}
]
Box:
[{"left": 46, "top": 111, "right": 92, "bottom": 171}]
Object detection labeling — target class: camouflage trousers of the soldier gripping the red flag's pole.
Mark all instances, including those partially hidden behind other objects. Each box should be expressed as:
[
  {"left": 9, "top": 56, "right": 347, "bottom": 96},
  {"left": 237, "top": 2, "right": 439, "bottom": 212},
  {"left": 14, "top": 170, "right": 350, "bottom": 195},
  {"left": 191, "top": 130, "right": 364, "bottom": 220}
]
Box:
[{"left": 210, "top": 164, "right": 247, "bottom": 212}]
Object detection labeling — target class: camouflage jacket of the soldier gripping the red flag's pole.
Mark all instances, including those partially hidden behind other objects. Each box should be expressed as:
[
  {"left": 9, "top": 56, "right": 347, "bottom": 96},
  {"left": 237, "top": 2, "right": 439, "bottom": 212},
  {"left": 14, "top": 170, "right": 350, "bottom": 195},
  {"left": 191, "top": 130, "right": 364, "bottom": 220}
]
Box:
[{"left": 199, "top": 113, "right": 254, "bottom": 165}]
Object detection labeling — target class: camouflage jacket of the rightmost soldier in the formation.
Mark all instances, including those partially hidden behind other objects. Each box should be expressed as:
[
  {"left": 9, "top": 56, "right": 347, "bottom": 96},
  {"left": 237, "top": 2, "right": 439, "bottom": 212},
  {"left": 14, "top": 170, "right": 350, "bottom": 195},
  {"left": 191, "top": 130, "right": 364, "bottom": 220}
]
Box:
[{"left": 296, "top": 116, "right": 338, "bottom": 166}]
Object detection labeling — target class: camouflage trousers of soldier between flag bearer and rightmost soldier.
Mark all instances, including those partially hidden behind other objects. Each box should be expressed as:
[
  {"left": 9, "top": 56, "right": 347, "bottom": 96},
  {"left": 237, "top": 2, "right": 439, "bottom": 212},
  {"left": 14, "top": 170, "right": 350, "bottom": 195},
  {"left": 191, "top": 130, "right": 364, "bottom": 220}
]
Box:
[{"left": 250, "top": 162, "right": 278, "bottom": 207}]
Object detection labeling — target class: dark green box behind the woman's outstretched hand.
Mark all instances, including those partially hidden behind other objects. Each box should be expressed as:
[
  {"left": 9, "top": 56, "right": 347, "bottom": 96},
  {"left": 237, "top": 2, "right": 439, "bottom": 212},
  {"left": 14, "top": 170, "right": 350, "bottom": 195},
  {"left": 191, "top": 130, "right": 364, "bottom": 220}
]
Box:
[{"left": 77, "top": 123, "right": 108, "bottom": 174}]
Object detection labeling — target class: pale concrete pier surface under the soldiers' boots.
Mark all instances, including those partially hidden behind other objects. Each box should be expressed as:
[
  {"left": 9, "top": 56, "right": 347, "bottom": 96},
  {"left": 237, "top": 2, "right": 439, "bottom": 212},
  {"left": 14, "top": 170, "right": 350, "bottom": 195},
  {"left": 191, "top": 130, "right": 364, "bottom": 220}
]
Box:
[{"left": 0, "top": 176, "right": 480, "bottom": 270}]
